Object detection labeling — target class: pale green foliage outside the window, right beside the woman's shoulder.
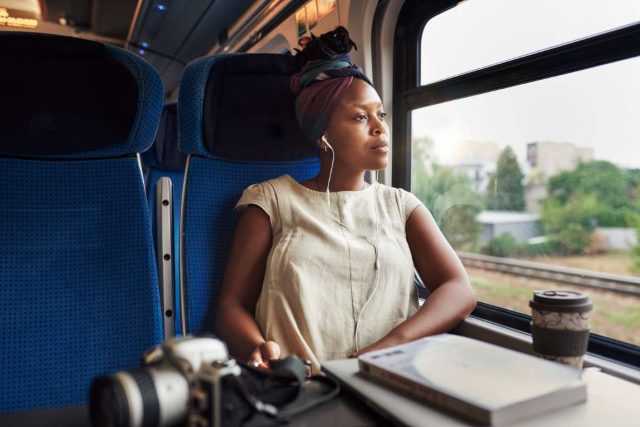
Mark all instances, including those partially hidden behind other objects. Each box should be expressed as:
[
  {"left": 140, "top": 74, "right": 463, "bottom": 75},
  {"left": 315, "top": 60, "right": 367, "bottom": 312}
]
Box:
[{"left": 411, "top": 138, "right": 482, "bottom": 249}]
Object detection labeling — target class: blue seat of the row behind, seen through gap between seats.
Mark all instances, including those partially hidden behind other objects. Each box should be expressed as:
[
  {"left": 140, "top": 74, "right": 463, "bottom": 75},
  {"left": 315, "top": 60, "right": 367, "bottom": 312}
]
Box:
[{"left": 140, "top": 102, "right": 187, "bottom": 331}]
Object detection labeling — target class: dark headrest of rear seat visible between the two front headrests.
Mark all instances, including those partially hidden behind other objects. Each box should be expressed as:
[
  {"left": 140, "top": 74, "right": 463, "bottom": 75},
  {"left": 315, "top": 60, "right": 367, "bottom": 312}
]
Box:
[{"left": 141, "top": 102, "right": 187, "bottom": 172}]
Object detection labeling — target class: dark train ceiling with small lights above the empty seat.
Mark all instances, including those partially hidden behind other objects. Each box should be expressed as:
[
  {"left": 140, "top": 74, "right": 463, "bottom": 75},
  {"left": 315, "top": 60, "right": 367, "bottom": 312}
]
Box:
[{"left": 0, "top": 0, "right": 260, "bottom": 97}]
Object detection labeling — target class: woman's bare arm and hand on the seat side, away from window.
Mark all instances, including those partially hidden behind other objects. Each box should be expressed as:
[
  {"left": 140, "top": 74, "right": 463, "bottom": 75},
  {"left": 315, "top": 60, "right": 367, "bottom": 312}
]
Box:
[{"left": 216, "top": 205, "right": 280, "bottom": 365}]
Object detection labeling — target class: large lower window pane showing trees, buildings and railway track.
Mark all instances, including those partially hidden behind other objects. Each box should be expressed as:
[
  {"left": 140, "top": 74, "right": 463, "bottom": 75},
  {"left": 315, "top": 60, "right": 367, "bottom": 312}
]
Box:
[{"left": 411, "top": 58, "right": 640, "bottom": 345}]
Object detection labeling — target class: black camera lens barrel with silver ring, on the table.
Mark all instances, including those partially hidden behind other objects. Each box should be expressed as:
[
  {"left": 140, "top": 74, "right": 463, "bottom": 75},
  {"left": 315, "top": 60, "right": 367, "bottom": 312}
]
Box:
[{"left": 89, "top": 370, "right": 161, "bottom": 427}]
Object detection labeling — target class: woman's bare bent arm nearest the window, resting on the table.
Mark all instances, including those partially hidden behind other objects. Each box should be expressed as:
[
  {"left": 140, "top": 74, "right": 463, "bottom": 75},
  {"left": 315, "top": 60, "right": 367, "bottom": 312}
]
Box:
[{"left": 359, "top": 206, "right": 476, "bottom": 354}]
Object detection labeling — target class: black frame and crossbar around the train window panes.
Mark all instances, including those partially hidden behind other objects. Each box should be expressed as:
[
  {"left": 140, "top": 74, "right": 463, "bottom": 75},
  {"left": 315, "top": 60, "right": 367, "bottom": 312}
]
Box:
[{"left": 392, "top": 0, "right": 640, "bottom": 368}]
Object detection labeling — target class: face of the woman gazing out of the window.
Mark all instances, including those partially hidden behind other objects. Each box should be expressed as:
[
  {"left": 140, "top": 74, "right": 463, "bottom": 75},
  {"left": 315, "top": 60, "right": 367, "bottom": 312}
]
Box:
[{"left": 319, "top": 79, "right": 389, "bottom": 171}]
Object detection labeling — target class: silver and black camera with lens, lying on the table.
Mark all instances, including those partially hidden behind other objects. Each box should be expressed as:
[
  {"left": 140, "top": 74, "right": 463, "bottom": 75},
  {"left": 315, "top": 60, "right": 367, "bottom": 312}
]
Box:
[{"left": 89, "top": 337, "right": 248, "bottom": 427}]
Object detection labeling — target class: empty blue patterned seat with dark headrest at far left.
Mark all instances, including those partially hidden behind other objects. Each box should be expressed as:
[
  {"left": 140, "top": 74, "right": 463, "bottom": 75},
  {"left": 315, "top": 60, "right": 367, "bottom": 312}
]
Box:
[{"left": 0, "top": 32, "right": 163, "bottom": 412}]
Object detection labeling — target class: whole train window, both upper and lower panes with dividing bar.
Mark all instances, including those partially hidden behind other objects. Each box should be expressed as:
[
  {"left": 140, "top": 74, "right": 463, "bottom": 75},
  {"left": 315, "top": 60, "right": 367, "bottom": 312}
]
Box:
[{"left": 404, "top": 0, "right": 640, "bottom": 352}]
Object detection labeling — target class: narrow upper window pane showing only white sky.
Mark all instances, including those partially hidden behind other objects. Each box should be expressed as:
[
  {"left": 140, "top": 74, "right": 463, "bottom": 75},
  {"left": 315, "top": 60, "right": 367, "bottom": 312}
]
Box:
[{"left": 420, "top": 0, "right": 640, "bottom": 84}]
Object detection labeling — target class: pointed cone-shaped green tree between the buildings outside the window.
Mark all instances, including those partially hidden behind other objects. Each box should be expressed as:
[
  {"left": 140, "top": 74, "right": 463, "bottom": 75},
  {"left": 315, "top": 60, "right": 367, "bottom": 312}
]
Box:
[{"left": 486, "top": 146, "right": 526, "bottom": 211}]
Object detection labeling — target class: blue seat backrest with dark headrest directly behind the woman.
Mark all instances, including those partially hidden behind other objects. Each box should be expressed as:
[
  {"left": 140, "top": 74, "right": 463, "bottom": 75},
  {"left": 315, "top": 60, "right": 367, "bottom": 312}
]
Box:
[{"left": 178, "top": 54, "right": 319, "bottom": 333}]
